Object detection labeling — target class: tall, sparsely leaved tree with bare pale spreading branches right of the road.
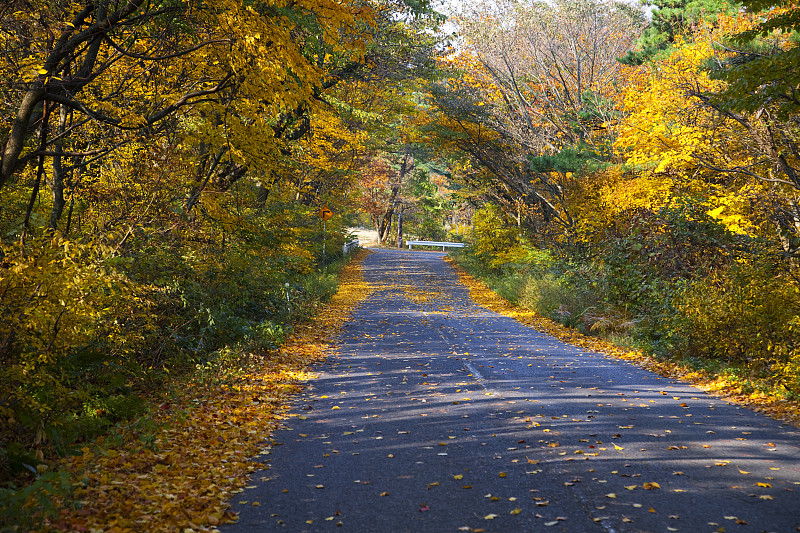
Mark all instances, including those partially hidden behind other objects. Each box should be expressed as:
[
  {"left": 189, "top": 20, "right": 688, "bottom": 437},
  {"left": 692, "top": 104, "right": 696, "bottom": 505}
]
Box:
[{"left": 432, "top": 0, "right": 639, "bottom": 242}]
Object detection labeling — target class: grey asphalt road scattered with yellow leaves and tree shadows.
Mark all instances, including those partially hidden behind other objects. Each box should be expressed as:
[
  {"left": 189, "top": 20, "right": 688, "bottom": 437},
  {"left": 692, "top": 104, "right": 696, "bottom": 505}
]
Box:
[{"left": 221, "top": 250, "right": 800, "bottom": 533}]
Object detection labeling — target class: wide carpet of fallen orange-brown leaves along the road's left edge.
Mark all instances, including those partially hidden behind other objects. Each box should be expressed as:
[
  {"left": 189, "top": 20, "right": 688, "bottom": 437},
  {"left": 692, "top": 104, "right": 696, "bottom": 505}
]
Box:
[{"left": 36, "top": 252, "right": 371, "bottom": 533}]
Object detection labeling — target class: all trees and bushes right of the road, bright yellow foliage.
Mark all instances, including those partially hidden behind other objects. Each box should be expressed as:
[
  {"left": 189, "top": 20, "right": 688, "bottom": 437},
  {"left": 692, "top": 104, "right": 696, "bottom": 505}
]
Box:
[{"left": 428, "top": 0, "right": 800, "bottom": 406}]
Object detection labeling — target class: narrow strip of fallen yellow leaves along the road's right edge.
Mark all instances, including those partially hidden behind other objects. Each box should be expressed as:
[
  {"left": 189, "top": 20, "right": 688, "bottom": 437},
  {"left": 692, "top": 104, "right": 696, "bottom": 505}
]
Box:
[{"left": 448, "top": 259, "right": 800, "bottom": 427}]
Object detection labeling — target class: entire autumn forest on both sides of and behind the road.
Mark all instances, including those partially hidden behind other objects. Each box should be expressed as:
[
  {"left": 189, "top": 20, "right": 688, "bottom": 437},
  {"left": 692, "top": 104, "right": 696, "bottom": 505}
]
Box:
[{"left": 0, "top": 0, "right": 800, "bottom": 524}]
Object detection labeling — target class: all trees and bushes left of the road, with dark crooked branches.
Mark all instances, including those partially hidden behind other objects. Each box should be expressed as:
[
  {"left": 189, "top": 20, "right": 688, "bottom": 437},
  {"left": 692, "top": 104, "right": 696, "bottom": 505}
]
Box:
[{"left": 0, "top": 0, "right": 438, "bottom": 508}]
